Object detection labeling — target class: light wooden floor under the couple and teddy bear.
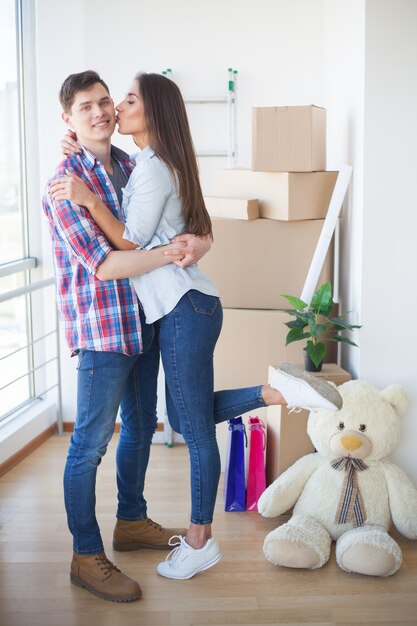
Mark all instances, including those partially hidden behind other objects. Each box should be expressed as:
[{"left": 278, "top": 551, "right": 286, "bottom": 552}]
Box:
[{"left": 0, "top": 435, "right": 417, "bottom": 626}]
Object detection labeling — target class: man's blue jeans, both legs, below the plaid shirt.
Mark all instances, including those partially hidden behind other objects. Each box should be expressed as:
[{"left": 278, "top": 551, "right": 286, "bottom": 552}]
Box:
[{"left": 64, "top": 308, "right": 159, "bottom": 554}]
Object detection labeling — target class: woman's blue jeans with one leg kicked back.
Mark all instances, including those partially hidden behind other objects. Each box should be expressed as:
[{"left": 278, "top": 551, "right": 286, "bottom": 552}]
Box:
[{"left": 158, "top": 290, "right": 265, "bottom": 524}]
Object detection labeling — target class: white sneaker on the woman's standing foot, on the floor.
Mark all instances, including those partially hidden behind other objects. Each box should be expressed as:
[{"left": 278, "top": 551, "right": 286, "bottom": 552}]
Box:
[{"left": 156, "top": 535, "right": 222, "bottom": 580}]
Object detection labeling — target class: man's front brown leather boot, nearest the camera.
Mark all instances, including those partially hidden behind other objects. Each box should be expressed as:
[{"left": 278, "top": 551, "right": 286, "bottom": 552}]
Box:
[{"left": 71, "top": 552, "right": 142, "bottom": 602}]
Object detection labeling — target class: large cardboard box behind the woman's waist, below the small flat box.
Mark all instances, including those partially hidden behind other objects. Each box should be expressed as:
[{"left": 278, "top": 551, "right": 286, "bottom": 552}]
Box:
[{"left": 198, "top": 218, "right": 333, "bottom": 309}]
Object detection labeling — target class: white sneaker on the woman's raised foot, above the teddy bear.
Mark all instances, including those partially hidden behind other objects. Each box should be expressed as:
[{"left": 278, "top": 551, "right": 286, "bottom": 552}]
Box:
[{"left": 271, "top": 363, "right": 343, "bottom": 411}]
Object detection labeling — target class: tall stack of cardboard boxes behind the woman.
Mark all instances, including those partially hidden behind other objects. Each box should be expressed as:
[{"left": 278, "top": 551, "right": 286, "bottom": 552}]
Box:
[{"left": 199, "top": 106, "right": 344, "bottom": 478}]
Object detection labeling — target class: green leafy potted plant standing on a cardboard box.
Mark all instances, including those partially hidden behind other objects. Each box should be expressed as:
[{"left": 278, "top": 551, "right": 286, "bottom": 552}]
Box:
[{"left": 283, "top": 282, "right": 360, "bottom": 372}]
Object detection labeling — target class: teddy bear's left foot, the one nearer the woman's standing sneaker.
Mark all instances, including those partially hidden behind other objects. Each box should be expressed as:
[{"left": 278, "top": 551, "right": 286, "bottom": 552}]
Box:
[{"left": 264, "top": 515, "right": 331, "bottom": 569}]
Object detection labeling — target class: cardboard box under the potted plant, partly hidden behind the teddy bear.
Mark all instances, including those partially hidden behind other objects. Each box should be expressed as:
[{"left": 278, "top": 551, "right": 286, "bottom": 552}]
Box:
[{"left": 266, "top": 363, "right": 351, "bottom": 485}]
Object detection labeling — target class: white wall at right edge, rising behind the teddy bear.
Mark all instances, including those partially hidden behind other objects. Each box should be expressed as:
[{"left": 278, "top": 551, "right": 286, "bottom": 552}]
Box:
[{"left": 360, "top": 0, "right": 417, "bottom": 482}]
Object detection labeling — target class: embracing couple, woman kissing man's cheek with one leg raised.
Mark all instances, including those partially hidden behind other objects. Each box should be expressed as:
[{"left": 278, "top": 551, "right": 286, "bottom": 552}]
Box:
[{"left": 43, "top": 71, "right": 341, "bottom": 602}]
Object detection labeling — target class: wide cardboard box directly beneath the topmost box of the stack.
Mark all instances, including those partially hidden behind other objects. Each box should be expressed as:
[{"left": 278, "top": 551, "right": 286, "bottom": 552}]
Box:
[{"left": 214, "top": 169, "right": 338, "bottom": 221}]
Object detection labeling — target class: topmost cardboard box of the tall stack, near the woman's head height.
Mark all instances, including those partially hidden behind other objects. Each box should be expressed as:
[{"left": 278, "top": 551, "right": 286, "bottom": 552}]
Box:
[{"left": 252, "top": 105, "right": 326, "bottom": 172}]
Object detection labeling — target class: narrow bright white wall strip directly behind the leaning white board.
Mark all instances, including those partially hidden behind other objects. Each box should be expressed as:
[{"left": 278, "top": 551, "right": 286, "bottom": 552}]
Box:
[{"left": 324, "top": 0, "right": 365, "bottom": 378}]
